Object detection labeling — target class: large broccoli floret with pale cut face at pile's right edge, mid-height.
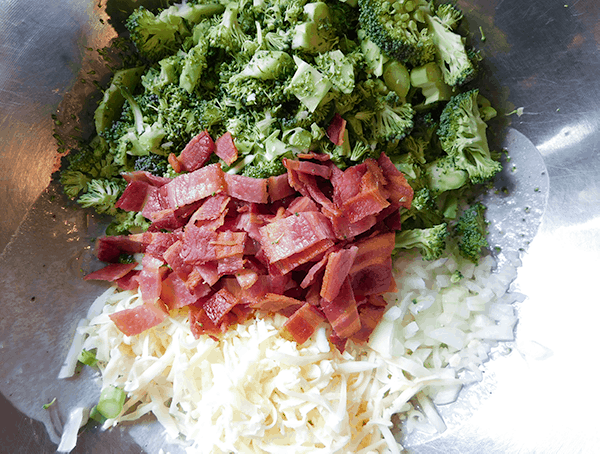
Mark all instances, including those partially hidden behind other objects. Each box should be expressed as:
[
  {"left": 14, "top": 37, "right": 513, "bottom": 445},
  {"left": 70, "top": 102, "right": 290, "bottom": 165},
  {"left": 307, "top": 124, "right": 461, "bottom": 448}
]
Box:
[{"left": 437, "top": 89, "right": 502, "bottom": 184}]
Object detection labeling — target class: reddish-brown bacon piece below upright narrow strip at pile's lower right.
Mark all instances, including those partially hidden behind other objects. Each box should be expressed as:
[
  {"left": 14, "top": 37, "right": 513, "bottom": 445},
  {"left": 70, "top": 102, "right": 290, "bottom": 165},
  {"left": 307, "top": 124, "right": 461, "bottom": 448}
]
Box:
[{"left": 321, "top": 278, "right": 361, "bottom": 339}]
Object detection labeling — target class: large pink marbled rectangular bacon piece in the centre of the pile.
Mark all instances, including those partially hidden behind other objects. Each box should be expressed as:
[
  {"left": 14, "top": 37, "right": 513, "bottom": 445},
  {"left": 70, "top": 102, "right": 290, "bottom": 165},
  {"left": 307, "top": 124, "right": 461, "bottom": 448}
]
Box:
[{"left": 259, "top": 211, "right": 334, "bottom": 263}]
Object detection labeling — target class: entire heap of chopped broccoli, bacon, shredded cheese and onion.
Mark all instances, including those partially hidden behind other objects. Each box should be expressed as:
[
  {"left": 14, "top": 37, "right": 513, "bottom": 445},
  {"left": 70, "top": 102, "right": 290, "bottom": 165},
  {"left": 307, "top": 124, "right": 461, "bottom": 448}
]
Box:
[{"left": 56, "top": 0, "right": 514, "bottom": 452}]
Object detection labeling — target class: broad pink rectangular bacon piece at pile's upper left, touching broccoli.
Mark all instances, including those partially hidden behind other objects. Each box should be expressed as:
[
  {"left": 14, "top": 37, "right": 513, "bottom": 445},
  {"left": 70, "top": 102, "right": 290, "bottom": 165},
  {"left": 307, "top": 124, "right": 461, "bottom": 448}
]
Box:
[{"left": 160, "top": 164, "right": 227, "bottom": 208}]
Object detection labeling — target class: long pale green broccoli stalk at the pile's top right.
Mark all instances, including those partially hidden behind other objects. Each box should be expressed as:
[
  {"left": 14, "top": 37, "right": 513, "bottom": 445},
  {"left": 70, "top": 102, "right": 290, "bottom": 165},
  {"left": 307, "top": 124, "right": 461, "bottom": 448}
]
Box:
[{"left": 427, "top": 6, "right": 477, "bottom": 86}]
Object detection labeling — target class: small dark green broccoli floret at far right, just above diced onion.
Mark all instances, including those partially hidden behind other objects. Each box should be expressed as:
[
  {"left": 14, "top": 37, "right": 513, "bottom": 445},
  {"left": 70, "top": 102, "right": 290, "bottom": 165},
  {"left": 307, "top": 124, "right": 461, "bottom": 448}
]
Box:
[{"left": 454, "top": 203, "right": 489, "bottom": 264}]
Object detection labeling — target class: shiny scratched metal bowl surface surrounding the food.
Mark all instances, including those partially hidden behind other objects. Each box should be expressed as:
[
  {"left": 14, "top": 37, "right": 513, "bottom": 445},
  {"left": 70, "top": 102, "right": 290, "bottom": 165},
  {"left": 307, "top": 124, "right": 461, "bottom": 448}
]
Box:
[{"left": 0, "top": 0, "right": 600, "bottom": 454}]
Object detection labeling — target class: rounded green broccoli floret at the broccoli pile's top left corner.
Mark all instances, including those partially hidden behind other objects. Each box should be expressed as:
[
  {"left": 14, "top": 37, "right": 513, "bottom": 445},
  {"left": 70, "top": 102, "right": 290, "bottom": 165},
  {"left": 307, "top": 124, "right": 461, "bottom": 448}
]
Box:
[{"left": 125, "top": 6, "right": 191, "bottom": 61}]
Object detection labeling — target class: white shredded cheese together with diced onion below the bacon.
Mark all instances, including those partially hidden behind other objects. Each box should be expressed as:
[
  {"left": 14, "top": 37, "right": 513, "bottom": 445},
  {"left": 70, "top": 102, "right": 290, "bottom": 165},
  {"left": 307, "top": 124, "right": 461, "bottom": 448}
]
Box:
[{"left": 69, "top": 248, "right": 518, "bottom": 454}]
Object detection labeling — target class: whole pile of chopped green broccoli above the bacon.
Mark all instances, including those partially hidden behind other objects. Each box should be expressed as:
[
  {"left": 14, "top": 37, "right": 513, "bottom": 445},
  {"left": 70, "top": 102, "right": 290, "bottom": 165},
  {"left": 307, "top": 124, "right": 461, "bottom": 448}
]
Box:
[{"left": 61, "top": 0, "right": 500, "bottom": 261}]
